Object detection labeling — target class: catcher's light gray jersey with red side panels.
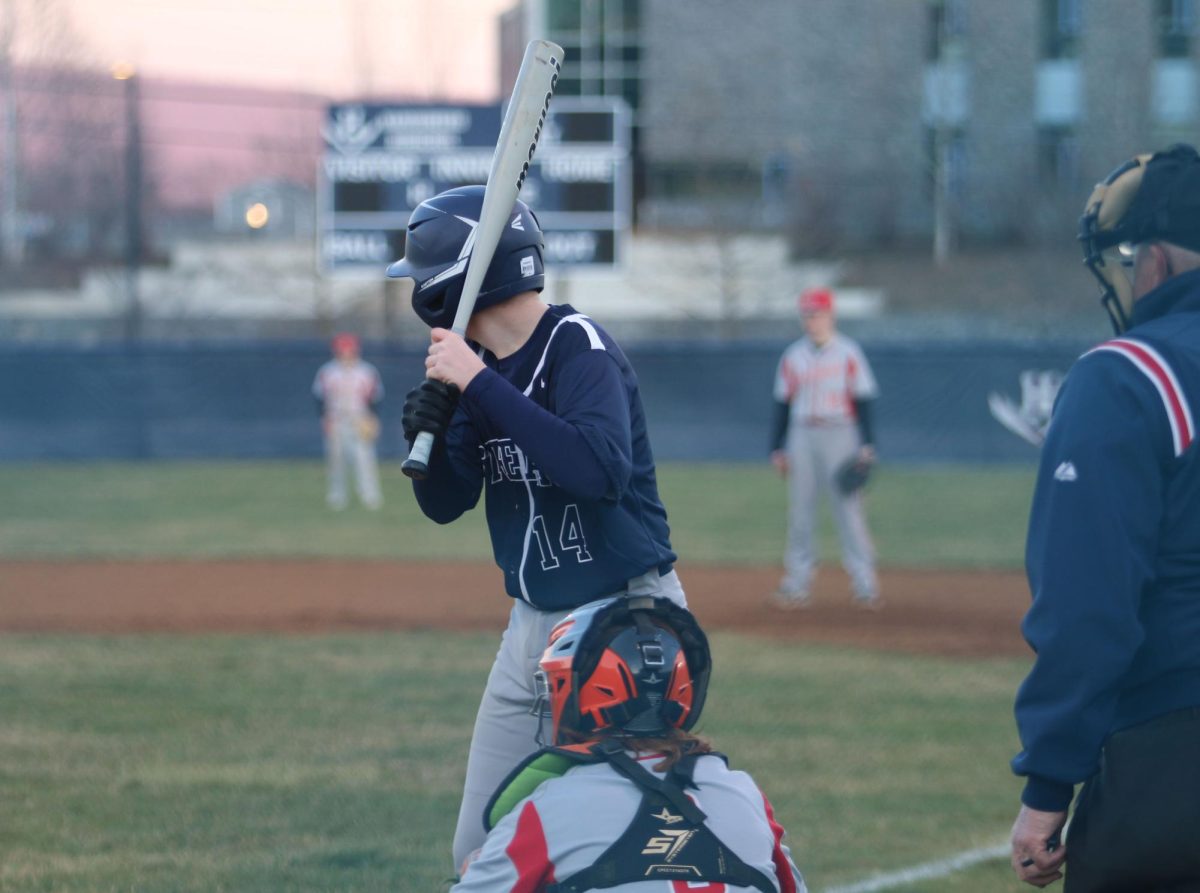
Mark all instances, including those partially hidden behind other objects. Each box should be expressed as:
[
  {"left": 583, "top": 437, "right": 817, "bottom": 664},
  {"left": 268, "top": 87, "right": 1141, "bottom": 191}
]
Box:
[{"left": 451, "top": 755, "right": 808, "bottom": 893}]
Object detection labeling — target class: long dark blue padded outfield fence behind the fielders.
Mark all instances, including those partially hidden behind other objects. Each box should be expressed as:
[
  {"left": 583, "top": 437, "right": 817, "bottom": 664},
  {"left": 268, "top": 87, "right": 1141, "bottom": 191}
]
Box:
[{"left": 0, "top": 341, "right": 1087, "bottom": 462}]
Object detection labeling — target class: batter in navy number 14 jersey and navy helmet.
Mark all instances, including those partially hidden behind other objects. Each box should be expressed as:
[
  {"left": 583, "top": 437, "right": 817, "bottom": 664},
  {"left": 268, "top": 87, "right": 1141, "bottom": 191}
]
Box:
[{"left": 389, "top": 186, "right": 684, "bottom": 865}]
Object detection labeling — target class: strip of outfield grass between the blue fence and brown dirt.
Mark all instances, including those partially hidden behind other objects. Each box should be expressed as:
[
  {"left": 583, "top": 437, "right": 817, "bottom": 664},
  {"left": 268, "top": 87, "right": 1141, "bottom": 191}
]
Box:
[{"left": 0, "top": 462, "right": 1033, "bottom": 568}]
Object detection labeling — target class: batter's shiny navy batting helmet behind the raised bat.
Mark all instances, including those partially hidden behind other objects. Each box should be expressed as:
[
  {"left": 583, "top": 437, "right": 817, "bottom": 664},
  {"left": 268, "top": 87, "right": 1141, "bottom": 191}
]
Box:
[{"left": 388, "top": 186, "right": 546, "bottom": 328}]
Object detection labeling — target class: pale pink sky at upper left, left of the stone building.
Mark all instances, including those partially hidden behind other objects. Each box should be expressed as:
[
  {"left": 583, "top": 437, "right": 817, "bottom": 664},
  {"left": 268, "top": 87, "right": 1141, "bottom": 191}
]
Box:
[{"left": 18, "top": 0, "right": 517, "bottom": 102}]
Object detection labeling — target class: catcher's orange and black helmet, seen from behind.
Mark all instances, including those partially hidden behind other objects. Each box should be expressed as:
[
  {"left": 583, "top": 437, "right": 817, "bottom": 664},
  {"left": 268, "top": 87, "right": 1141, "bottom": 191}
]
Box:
[{"left": 536, "top": 597, "right": 712, "bottom": 744}]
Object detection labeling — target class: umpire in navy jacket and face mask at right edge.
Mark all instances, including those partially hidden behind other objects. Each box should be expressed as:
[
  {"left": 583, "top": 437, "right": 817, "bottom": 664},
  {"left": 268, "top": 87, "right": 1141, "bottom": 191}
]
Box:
[{"left": 1012, "top": 145, "right": 1200, "bottom": 893}]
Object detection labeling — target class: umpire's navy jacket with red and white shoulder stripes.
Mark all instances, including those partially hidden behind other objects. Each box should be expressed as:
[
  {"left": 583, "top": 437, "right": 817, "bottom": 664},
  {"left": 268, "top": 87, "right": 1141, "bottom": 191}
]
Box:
[{"left": 1013, "top": 271, "right": 1200, "bottom": 811}]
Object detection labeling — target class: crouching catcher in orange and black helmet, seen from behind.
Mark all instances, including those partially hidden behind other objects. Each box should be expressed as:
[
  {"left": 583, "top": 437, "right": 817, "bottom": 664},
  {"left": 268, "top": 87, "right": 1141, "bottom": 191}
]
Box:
[{"left": 451, "top": 597, "right": 806, "bottom": 893}]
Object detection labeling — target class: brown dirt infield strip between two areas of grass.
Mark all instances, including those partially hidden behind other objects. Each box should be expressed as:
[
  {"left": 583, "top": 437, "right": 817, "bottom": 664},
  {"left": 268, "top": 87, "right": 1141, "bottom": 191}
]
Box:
[{"left": 0, "top": 561, "right": 1028, "bottom": 655}]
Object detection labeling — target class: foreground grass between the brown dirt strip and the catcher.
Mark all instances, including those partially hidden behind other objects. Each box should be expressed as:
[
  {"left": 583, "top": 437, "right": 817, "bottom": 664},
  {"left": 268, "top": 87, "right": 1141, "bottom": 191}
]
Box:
[{"left": 0, "top": 633, "right": 1024, "bottom": 893}]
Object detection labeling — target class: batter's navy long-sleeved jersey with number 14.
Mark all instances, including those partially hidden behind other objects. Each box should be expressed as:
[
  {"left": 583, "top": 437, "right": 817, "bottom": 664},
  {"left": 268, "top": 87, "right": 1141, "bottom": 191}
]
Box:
[{"left": 413, "top": 305, "right": 676, "bottom": 610}]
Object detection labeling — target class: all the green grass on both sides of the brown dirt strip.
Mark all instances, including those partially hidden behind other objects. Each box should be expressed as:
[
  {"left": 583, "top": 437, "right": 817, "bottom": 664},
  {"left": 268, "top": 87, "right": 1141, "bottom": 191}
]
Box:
[{"left": 0, "top": 462, "right": 1032, "bottom": 893}]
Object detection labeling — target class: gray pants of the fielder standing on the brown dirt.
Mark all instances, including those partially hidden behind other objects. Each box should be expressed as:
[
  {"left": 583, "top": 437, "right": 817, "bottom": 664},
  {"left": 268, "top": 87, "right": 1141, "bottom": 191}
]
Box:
[{"left": 779, "top": 422, "right": 880, "bottom": 600}]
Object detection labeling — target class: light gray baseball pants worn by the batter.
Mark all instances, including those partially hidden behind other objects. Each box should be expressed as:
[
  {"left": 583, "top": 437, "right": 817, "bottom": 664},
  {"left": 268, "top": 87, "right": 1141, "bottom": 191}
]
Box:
[{"left": 454, "top": 569, "right": 688, "bottom": 870}]
